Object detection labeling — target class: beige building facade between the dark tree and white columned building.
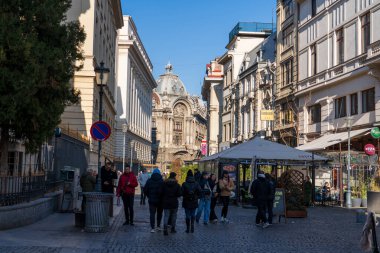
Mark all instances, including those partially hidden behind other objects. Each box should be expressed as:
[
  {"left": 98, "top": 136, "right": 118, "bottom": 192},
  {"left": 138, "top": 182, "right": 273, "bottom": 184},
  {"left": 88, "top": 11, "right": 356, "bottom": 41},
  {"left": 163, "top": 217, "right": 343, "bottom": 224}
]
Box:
[{"left": 60, "top": 0, "right": 123, "bottom": 169}]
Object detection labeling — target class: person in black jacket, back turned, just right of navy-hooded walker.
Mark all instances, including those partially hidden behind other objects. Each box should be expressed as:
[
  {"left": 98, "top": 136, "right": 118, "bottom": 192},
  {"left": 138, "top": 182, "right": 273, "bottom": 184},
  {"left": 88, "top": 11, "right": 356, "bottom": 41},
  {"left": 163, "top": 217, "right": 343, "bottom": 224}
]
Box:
[{"left": 162, "top": 172, "right": 181, "bottom": 235}]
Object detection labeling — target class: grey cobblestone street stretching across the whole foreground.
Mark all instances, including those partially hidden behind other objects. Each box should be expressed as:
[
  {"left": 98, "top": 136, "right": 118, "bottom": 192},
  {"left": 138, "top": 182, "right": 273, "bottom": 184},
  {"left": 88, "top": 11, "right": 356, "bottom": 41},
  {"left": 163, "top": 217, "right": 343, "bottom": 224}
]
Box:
[{"left": 0, "top": 202, "right": 378, "bottom": 253}]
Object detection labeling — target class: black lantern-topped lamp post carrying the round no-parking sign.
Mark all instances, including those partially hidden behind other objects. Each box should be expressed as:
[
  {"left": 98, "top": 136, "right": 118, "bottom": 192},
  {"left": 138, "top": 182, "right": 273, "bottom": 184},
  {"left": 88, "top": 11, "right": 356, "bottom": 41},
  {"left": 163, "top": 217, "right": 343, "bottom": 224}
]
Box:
[{"left": 95, "top": 61, "right": 110, "bottom": 192}]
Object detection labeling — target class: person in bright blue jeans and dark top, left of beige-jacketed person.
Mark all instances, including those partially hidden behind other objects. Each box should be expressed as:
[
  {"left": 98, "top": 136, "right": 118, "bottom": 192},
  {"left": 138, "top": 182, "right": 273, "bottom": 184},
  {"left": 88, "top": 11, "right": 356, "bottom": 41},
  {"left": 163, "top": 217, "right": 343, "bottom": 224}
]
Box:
[{"left": 195, "top": 171, "right": 211, "bottom": 225}]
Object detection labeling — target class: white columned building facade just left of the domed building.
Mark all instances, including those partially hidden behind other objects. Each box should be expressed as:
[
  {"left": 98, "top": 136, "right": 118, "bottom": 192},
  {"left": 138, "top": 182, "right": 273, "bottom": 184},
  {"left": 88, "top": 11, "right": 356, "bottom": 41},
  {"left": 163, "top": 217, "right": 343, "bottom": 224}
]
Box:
[{"left": 115, "top": 16, "right": 157, "bottom": 170}]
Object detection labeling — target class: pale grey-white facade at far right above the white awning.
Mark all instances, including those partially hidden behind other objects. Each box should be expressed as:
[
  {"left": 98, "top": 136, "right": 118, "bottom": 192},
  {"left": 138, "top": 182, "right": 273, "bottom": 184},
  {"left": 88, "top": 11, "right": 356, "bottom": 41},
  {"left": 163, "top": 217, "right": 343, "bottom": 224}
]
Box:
[{"left": 296, "top": 0, "right": 380, "bottom": 146}]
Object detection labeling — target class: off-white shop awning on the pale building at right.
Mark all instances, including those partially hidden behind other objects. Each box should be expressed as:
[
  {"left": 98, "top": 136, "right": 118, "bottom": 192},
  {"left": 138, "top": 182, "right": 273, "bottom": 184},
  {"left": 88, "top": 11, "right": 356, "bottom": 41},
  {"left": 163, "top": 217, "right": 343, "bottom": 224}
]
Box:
[{"left": 296, "top": 128, "right": 371, "bottom": 151}]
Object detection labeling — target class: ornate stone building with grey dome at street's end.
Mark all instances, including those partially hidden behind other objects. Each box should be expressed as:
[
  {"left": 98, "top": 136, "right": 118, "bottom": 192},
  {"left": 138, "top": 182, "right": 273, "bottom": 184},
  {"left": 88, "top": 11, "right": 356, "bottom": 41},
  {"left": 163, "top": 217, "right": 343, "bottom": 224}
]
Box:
[{"left": 152, "top": 64, "right": 207, "bottom": 175}]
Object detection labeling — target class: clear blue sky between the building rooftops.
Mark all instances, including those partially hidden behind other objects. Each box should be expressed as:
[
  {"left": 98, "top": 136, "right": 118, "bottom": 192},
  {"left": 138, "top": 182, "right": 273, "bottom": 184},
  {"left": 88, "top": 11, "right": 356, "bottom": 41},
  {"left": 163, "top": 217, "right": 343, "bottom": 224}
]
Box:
[{"left": 121, "top": 0, "right": 276, "bottom": 95}]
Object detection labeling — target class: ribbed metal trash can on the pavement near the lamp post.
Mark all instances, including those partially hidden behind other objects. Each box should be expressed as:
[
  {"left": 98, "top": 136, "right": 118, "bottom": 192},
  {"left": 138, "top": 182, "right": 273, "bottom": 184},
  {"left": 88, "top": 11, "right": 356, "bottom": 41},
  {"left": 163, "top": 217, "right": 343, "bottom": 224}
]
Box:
[{"left": 83, "top": 192, "right": 113, "bottom": 233}]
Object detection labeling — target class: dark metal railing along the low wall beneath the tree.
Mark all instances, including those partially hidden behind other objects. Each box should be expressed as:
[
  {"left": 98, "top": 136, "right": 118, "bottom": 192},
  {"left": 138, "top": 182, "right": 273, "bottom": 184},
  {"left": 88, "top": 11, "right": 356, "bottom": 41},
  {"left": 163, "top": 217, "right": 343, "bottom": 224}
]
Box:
[{"left": 0, "top": 173, "right": 62, "bottom": 207}]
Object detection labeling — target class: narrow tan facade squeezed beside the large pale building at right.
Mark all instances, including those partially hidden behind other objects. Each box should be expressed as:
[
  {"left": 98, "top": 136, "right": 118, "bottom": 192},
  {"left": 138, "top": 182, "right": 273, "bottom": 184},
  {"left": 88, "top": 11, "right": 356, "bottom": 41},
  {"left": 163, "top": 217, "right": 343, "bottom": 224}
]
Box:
[{"left": 274, "top": 0, "right": 299, "bottom": 147}]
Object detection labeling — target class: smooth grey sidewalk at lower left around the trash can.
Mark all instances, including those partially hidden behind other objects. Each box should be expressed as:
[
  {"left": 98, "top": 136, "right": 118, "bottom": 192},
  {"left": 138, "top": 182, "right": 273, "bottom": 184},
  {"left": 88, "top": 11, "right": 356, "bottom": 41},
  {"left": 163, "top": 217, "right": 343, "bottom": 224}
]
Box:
[{"left": 0, "top": 198, "right": 122, "bottom": 253}]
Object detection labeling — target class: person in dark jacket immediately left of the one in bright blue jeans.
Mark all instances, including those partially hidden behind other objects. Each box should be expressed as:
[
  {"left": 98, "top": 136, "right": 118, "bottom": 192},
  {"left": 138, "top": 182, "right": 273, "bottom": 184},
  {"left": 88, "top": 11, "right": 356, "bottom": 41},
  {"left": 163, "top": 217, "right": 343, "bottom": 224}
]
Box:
[{"left": 181, "top": 170, "right": 201, "bottom": 233}]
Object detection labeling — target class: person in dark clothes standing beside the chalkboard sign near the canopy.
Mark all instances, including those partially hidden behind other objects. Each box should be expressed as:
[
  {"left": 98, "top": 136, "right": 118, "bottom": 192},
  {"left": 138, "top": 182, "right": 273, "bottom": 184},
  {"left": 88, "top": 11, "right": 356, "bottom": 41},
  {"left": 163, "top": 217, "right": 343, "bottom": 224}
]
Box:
[{"left": 251, "top": 171, "right": 270, "bottom": 228}]
